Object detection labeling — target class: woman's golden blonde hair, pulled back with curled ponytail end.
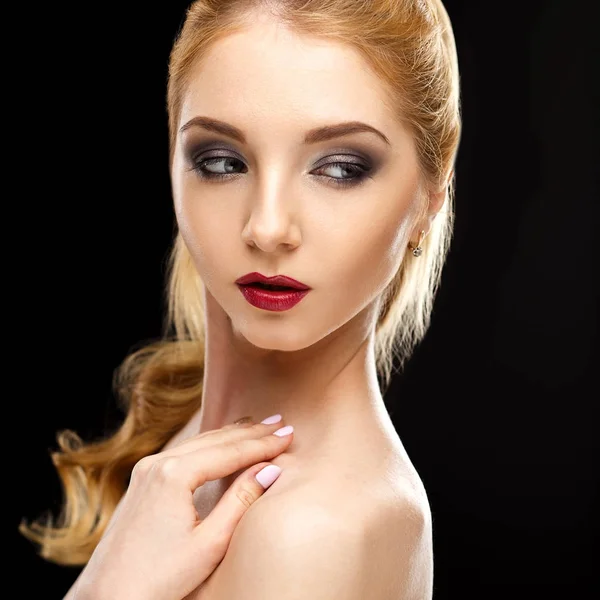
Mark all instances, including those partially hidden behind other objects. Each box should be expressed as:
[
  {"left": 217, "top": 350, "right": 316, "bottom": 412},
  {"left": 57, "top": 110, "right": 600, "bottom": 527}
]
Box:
[{"left": 19, "top": 0, "right": 462, "bottom": 565}]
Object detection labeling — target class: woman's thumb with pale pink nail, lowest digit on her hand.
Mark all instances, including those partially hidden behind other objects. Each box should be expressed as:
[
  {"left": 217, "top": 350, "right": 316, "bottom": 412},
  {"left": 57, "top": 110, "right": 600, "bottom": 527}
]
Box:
[{"left": 194, "top": 462, "right": 281, "bottom": 577}]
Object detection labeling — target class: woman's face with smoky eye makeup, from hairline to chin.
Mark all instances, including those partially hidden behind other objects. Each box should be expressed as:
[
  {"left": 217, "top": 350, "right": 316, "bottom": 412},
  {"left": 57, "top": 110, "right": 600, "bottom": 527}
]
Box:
[{"left": 171, "top": 15, "right": 419, "bottom": 350}]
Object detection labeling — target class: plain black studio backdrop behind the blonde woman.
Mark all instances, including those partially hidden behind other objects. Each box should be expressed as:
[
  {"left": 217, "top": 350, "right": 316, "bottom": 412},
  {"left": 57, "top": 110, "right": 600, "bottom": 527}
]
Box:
[{"left": 12, "top": 0, "right": 600, "bottom": 600}]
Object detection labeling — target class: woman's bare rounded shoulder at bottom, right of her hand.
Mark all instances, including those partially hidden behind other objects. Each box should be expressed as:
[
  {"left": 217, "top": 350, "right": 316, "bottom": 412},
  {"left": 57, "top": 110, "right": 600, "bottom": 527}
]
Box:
[{"left": 196, "top": 454, "right": 433, "bottom": 600}]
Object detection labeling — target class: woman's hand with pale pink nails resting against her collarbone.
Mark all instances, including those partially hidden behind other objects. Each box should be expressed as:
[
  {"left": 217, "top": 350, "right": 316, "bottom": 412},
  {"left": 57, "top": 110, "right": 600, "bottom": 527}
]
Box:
[{"left": 75, "top": 421, "right": 293, "bottom": 600}]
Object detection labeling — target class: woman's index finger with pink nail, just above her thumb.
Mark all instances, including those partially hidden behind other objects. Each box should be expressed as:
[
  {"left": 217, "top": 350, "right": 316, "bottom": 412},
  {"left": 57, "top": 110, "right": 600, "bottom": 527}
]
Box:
[{"left": 172, "top": 425, "right": 294, "bottom": 492}]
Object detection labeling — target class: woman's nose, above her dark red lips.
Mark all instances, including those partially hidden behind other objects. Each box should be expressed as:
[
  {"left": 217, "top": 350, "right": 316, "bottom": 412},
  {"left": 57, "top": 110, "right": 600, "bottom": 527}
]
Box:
[{"left": 242, "top": 193, "right": 301, "bottom": 252}]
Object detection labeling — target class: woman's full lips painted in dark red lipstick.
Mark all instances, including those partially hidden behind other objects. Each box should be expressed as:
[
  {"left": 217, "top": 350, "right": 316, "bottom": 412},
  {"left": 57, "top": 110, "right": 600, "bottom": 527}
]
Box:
[{"left": 236, "top": 272, "right": 311, "bottom": 311}]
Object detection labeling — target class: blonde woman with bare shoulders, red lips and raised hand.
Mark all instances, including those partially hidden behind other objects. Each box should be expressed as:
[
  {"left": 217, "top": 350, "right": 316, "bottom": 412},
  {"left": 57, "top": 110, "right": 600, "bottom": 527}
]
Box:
[{"left": 21, "top": 0, "right": 461, "bottom": 600}]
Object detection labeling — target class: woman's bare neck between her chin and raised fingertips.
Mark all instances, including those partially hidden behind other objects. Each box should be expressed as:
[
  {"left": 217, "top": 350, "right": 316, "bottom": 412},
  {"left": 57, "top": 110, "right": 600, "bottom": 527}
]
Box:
[{"left": 193, "top": 290, "right": 391, "bottom": 455}]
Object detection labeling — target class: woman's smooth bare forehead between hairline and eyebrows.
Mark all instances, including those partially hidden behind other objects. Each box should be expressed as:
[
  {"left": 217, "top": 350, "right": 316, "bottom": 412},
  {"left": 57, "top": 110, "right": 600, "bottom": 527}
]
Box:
[{"left": 179, "top": 20, "right": 400, "bottom": 136}]
